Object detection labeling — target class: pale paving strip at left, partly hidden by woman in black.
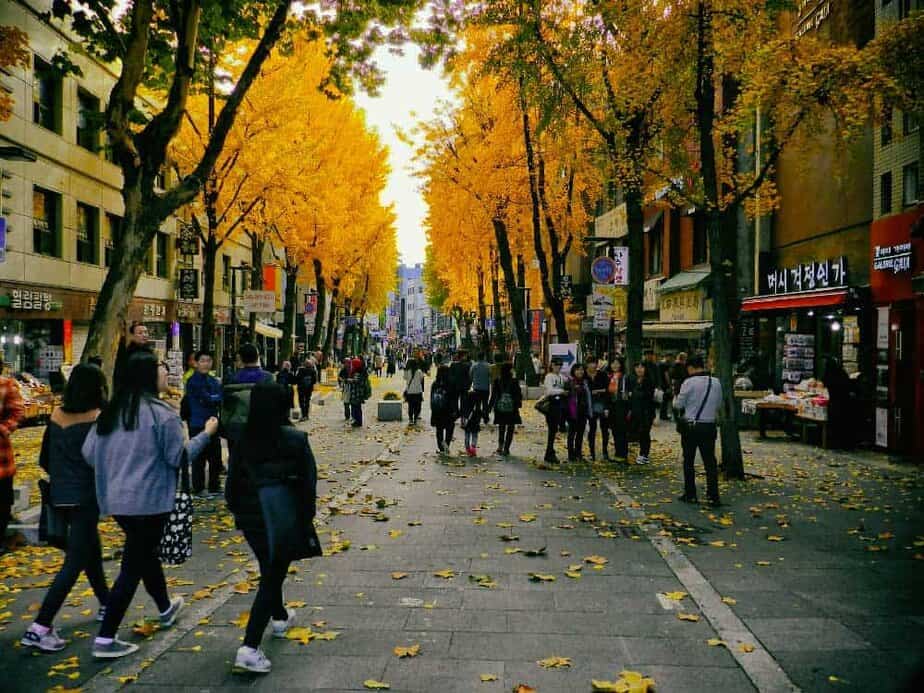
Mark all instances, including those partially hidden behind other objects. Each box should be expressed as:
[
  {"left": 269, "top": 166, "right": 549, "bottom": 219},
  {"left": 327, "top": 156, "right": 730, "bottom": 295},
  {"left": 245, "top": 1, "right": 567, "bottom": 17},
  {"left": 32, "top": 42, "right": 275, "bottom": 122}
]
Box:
[{"left": 82, "top": 430, "right": 417, "bottom": 693}]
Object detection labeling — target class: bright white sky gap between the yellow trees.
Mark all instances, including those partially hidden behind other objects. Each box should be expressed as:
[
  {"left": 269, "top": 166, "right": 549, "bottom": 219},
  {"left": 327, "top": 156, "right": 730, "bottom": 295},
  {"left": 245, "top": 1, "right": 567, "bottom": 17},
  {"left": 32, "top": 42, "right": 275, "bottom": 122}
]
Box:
[{"left": 356, "top": 44, "right": 450, "bottom": 265}]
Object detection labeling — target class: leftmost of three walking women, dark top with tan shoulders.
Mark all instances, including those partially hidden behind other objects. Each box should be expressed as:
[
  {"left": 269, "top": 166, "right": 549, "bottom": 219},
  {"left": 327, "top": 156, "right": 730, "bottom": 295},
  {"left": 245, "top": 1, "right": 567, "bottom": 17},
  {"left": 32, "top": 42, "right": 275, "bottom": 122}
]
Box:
[{"left": 20, "top": 364, "right": 109, "bottom": 652}]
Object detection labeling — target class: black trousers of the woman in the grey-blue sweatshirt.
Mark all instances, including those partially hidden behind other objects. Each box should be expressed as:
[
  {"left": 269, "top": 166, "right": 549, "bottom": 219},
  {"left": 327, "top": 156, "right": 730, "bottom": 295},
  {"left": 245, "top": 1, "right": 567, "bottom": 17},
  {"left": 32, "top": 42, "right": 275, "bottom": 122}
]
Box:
[{"left": 99, "top": 513, "right": 170, "bottom": 638}]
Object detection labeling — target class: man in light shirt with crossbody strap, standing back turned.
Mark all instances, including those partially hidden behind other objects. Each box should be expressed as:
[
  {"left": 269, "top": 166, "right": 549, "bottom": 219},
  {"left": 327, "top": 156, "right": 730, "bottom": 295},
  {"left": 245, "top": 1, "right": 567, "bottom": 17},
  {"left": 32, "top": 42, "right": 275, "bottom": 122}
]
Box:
[{"left": 674, "top": 354, "right": 722, "bottom": 505}]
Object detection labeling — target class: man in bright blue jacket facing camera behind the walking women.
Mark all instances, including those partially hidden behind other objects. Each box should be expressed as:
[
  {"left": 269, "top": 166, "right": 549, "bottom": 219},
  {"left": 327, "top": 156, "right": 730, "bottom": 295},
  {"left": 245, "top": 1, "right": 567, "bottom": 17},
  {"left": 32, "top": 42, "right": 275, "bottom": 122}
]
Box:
[{"left": 186, "top": 351, "right": 222, "bottom": 495}]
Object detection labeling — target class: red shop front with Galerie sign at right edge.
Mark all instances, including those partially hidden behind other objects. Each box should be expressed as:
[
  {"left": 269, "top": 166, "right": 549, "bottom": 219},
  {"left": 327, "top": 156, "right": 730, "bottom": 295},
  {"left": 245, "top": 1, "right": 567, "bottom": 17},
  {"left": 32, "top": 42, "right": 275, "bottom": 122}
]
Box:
[{"left": 870, "top": 205, "right": 924, "bottom": 461}]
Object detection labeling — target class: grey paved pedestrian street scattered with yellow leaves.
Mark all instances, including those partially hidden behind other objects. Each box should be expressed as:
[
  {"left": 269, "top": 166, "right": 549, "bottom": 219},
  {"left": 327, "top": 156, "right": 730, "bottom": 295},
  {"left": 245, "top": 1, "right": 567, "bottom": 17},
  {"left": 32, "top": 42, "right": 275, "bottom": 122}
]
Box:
[{"left": 0, "top": 381, "right": 924, "bottom": 692}]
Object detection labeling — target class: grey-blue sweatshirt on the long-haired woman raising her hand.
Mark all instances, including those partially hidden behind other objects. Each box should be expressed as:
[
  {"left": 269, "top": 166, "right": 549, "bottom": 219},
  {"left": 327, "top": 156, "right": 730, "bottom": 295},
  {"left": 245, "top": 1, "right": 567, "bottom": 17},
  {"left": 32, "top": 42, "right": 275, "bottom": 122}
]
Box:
[{"left": 83, "top": 399, "right": 209, "bottom": 515}]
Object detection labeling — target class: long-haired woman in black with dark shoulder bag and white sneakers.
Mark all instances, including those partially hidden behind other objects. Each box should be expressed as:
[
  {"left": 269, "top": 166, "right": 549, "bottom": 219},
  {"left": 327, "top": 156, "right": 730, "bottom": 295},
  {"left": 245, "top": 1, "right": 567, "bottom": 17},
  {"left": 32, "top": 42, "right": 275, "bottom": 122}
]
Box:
[{"left": 225, "top": 383, "right": 321, "bottom": 674}]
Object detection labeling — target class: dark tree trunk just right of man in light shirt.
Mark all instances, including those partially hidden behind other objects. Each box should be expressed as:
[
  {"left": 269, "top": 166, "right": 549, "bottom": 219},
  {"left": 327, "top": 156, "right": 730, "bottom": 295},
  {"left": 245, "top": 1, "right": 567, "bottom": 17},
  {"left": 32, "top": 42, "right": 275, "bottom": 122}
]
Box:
[{"left": 696, "top": 0, "right": 744, "bottom": 479}]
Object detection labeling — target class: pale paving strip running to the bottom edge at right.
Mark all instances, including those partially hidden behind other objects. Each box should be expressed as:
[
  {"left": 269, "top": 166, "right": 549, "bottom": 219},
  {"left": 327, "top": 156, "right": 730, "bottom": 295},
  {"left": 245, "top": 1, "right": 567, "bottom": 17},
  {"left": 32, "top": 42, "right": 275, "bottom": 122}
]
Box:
[{"left": 603, "top": 480, "right": 800, "bottom": 693}]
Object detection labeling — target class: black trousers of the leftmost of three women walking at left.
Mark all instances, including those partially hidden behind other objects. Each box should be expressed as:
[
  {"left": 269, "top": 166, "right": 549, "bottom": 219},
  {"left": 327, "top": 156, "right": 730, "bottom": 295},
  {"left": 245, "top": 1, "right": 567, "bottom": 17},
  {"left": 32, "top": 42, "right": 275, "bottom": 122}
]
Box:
[{"left": 35, "top": 503, "right": 109, "bottom": 628}]
